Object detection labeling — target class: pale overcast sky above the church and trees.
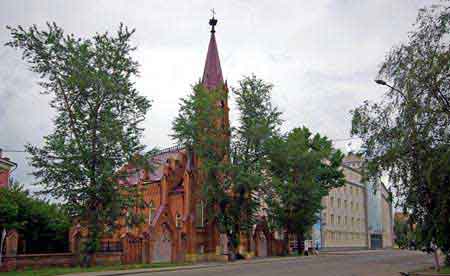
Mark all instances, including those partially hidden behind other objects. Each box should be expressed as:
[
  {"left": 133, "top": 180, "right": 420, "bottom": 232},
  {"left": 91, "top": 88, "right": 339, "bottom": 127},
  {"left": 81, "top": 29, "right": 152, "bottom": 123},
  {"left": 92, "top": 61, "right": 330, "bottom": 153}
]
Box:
[{"left": 0, "top": 0, "right": 436, "bottom": 190}]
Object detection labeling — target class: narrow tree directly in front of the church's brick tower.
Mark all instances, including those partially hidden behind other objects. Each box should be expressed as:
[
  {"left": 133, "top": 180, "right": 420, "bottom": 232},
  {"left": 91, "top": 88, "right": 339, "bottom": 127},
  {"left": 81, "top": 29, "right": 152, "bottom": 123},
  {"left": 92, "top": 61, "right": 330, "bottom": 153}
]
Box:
[{"left": 172, "top": 83, "right": 230, "bottom": 250}]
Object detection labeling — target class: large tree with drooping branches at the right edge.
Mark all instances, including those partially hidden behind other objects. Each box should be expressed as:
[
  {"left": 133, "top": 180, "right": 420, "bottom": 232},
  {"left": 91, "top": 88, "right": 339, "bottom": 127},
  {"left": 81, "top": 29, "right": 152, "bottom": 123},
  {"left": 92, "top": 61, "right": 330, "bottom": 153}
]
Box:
[{"left": 352, "top": 4, "right": 450, "bottom": 263}]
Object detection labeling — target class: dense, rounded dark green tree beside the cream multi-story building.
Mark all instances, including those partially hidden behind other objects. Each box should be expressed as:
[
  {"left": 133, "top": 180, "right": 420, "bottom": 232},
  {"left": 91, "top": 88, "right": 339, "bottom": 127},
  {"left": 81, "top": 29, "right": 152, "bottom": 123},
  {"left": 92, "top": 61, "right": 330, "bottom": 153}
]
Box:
[{"left": 268, "top": 127, "right": 345, "bottom": 253}]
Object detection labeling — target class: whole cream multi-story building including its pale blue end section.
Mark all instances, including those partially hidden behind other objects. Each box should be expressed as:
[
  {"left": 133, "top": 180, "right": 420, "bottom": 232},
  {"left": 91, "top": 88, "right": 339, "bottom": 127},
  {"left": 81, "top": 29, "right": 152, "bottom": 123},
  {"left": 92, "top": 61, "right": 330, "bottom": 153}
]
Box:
[{"left": 312, "top": 154, "right": 393, "bottom": 250}]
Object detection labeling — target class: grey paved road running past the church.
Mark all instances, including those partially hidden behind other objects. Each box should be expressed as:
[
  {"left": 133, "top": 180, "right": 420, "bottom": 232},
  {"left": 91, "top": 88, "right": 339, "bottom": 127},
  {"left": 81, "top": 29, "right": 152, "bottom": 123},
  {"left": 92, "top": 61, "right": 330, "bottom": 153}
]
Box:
[{"left": 132, "top": 250, "right": 433, "bottom": 276}]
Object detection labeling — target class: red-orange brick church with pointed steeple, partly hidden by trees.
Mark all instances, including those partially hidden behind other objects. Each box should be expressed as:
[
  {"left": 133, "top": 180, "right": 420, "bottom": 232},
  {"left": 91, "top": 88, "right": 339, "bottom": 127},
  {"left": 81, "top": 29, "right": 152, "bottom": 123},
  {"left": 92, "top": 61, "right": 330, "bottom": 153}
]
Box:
[{"left": 70, "top": 17, "right": 273, "bottom": 263}]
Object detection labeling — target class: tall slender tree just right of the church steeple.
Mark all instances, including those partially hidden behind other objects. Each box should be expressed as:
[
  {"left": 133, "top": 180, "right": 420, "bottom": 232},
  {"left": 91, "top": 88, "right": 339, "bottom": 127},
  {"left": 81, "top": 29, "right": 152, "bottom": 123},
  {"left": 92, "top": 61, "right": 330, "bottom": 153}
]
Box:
[{"left": 230, "top": 75, "right": 282, "bottom": 254}]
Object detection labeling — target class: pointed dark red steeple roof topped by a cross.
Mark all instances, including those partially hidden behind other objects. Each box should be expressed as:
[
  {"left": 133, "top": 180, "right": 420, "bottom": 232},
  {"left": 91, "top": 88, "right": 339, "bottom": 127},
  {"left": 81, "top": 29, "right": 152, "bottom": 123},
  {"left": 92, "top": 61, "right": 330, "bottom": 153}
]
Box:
[{"left": 202, "top": 15, "right": 223, "bottom": 90}]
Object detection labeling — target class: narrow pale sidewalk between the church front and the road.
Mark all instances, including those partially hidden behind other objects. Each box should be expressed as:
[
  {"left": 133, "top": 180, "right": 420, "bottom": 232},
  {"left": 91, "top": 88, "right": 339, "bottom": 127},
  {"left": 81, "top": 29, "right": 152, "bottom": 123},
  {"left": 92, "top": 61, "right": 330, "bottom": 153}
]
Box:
[{"left": 59, "top": 256, "right": 314, "bottom": 276}]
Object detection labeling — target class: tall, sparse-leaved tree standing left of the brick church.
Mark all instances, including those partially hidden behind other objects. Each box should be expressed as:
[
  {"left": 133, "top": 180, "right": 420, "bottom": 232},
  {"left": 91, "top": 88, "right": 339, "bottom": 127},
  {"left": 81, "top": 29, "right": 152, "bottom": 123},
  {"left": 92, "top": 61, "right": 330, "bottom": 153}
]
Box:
[{"left": 6, "top": 23, "right": 150, "bottom": 258}]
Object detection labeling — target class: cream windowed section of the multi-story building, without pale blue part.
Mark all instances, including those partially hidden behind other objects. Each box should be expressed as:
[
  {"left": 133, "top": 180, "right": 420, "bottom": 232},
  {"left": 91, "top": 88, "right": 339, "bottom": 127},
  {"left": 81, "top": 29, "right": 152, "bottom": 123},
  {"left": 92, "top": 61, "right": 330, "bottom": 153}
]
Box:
[{"left": 313, "top": 155, "right": 368, "bottom": 249}]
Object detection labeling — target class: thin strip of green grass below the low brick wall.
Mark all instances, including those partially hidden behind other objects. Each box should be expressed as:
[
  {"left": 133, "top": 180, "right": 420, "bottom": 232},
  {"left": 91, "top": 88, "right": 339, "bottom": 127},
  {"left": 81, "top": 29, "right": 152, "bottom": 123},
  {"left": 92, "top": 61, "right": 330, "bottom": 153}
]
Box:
[{"left": 0, "top": 263, "right": 191, "bottom": 276}]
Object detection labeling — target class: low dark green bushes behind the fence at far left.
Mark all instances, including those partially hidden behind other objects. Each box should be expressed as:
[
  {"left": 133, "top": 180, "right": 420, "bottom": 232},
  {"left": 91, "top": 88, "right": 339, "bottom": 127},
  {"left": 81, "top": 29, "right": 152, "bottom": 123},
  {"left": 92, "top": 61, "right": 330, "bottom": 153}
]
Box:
[{"left": 0, "top": 184, "right": 70, "bottom": 253}]
